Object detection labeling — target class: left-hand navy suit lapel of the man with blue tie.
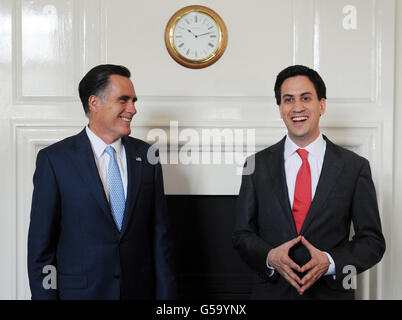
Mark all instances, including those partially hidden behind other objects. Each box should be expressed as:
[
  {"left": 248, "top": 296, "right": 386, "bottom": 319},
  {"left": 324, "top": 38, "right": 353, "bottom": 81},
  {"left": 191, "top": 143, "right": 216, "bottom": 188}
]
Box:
[{"left": 71, "top": 129, "right": 114, "bottom": 223}]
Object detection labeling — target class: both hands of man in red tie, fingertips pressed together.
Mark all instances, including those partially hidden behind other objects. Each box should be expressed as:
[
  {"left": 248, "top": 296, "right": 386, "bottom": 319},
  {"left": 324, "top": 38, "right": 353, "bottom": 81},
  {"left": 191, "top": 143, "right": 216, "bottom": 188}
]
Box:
[{"left": 268, "top": 236, "right": 330, "bottom": 295}]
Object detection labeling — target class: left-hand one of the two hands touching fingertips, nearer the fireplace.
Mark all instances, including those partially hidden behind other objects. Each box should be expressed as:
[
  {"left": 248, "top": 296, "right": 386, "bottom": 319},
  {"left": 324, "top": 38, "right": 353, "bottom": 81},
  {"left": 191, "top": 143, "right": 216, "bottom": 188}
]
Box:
[{"left": 268, "top": 236, "right": 301, "bottom": 293}]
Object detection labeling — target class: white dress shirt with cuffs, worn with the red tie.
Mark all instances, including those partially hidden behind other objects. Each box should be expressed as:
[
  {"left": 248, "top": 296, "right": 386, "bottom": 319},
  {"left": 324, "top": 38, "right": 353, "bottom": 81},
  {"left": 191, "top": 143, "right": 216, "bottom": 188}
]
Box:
[{"left": 267, "top": 134, "right": 335, "bottom": 275}]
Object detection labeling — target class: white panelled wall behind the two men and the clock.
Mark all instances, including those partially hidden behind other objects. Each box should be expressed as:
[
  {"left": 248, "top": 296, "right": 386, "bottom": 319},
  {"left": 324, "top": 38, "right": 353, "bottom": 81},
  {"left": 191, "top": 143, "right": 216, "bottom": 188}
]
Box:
[{"left": 0, "top": 0, "right": 402, "bottom": 299}]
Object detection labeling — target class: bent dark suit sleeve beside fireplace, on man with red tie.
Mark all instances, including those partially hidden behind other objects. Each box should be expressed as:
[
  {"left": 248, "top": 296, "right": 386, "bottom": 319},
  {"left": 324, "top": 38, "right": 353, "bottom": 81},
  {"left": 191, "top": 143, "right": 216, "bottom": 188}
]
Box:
[{"left": 232, "top": 163, "right": 273, "bottom": 280}]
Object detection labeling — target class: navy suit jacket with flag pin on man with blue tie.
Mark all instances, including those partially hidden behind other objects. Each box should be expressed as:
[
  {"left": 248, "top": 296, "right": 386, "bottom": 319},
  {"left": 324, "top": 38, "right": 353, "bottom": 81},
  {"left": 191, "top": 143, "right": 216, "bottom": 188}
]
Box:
[{"left": 28, "top": 129, "right": 176, "bottom": 299}]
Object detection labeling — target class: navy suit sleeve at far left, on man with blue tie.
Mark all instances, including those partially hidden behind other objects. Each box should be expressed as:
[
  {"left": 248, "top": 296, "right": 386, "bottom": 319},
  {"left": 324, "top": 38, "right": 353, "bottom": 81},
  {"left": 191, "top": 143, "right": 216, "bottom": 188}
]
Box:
[{"left": 28, "top": 150, "right": 60, "bottom": 299}]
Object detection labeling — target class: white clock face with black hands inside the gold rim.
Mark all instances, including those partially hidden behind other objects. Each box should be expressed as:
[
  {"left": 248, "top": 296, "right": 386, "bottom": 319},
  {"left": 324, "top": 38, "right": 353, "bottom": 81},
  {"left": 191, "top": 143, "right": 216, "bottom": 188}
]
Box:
[{"left": 173, "top": 11, "right": 221, "bottom": 61}]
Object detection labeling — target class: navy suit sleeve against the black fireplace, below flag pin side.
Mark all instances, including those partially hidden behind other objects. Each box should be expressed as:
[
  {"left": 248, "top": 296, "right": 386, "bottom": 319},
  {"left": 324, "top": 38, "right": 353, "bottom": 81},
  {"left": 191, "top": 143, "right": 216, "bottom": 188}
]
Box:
[{"left": 154, "top": 156, "right": 177, "bottom": 300}]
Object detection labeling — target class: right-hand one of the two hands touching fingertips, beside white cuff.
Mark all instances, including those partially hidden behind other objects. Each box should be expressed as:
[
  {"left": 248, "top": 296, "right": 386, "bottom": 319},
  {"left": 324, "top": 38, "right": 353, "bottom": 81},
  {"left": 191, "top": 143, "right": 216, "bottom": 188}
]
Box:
[{"left": 298, "top": 236, "right": 330, "bottom": 295}]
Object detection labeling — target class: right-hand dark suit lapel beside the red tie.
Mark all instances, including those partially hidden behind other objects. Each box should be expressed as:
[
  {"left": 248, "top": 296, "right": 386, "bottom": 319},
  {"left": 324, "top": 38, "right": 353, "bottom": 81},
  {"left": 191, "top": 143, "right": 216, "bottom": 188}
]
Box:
[{"left": 300, "top": 136, "right": 344, "bottom": 234}]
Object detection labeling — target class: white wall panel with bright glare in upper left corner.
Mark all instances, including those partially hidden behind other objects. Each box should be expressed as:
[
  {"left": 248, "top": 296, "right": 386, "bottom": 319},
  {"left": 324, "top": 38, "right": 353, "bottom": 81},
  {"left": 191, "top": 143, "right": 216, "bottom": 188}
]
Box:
[{"left": 16, "top": 0, "right": 80, "bottom": 97}]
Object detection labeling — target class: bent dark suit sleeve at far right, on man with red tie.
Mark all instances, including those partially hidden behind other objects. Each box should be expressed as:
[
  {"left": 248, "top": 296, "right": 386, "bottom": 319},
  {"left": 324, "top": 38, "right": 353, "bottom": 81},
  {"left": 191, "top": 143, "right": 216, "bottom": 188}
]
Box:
[{"left": 328, "top": 160, "right": 385, "bottom": 279}]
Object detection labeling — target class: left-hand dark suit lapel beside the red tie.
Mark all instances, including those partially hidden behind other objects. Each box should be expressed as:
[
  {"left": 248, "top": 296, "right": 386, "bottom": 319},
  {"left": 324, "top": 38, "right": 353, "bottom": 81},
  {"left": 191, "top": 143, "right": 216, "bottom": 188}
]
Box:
[{"left": 266, "top": 137, "right": 297, "bottom": 233}]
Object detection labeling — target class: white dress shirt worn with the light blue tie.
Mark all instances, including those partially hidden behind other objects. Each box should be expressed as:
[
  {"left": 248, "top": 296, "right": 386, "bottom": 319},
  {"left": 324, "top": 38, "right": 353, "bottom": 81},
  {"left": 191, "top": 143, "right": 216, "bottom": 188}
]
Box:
[{"left": 85, "top": 126, "right": 127, "bottom": 202}]
